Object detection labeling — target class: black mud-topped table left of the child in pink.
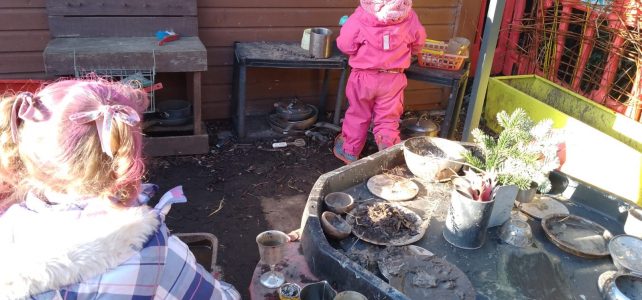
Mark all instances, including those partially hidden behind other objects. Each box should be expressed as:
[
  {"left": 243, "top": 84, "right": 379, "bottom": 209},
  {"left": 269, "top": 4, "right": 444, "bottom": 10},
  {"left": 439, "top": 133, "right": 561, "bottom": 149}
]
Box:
[{"left": 234, "top": 42, "right": 348, "bottom": 137}]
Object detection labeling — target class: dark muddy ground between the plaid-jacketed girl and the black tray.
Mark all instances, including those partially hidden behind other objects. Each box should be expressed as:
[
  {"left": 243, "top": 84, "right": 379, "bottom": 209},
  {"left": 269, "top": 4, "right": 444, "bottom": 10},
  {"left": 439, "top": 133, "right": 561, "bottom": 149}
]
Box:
[{"left": 147, "top": 119, "right": 342, "bottom": 299}]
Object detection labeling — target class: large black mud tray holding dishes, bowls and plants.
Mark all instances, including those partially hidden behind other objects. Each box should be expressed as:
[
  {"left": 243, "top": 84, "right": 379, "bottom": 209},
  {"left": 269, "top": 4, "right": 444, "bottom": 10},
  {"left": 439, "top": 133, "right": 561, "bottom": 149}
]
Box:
[{"left": 301, "top": 145, "right": 625, "bottom": 299}]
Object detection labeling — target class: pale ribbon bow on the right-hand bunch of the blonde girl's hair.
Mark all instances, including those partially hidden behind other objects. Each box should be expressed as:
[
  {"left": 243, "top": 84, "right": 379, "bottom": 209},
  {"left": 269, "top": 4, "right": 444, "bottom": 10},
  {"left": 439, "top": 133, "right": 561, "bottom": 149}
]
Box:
[{"left": 69, "top": 105, "right": 140, "bottom": 158}]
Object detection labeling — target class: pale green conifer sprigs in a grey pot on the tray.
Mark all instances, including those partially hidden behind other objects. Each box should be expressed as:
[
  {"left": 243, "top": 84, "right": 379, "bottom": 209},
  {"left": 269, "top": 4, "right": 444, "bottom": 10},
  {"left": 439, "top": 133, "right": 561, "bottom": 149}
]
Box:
[{"left": 463, "top": 108, "right": 559, "bottom": 227}]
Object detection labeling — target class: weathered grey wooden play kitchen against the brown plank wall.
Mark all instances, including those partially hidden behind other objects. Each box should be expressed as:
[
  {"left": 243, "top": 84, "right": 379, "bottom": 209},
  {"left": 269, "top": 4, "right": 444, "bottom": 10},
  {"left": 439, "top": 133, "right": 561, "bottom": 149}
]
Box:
[{"left": 44, "top": 0, "right": 209, "bottom": 156}]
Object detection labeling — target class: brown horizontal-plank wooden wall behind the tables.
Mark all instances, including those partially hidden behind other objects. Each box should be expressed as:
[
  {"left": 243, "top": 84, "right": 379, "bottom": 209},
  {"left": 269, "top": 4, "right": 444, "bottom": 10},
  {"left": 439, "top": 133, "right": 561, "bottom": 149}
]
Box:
[{"left": 0, "top": 0, "right": 480, "bottom": 119}]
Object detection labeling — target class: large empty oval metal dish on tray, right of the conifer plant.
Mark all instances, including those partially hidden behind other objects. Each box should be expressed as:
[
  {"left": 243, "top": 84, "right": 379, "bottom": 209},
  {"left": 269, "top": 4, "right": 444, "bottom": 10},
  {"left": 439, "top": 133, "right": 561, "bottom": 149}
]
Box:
[{"left": 542, "top": 214, "right": 613, "bottom": 258}]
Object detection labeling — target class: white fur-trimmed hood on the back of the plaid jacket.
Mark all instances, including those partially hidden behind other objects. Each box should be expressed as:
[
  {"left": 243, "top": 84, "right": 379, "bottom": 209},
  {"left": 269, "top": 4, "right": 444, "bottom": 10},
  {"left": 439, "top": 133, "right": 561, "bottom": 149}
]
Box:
[{"left": 0, "top": 195, "right": 161, "bottom": 299}]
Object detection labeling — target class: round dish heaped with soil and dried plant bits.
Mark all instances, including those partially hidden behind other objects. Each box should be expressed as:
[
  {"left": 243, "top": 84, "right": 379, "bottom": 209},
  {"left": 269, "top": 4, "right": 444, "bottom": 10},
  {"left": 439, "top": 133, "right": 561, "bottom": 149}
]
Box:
[{"left": 346, "top": 202, "right": 428, "bottom": 246}]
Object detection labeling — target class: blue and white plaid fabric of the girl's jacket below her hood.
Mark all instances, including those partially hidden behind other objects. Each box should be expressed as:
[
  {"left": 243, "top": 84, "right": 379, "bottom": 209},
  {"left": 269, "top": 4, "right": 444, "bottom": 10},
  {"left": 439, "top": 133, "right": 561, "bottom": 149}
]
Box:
[{"left": 31, "top": 225, "right": 240, "bottom": 300}]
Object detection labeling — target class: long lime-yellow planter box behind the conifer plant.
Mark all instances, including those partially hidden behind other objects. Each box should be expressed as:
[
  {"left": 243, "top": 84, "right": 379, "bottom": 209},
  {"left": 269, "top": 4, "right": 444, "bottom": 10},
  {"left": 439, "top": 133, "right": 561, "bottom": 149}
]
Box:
[{"left": 484, "top": 75, "right": 642, "bottom": 204}]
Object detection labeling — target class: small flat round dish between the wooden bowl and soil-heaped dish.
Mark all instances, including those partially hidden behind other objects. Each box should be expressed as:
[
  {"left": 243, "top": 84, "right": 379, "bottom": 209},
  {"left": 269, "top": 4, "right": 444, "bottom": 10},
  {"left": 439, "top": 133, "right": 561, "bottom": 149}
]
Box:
[{"left": 366, "top": 174, "right": 419, "bottom": 201}]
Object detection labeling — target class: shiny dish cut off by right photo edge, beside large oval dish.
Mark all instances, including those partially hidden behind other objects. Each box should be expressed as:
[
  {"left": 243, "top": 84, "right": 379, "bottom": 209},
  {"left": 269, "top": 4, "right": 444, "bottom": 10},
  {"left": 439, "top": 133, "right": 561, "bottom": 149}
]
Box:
[{"left": 609, "top": 234, "right": 642, "bottom": 276}]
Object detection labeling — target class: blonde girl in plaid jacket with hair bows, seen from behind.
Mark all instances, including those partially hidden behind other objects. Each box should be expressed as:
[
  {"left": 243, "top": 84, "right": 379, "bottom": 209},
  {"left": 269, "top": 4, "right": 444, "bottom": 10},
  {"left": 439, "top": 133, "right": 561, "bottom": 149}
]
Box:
[{"left": 0, "top": 80, "right": 239, "bottom": 299}]
